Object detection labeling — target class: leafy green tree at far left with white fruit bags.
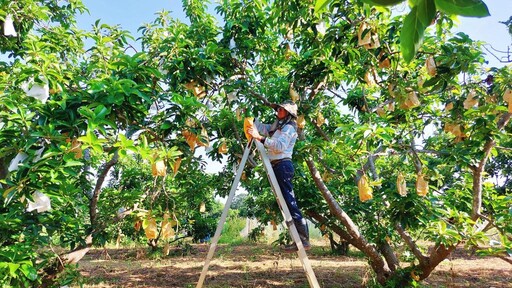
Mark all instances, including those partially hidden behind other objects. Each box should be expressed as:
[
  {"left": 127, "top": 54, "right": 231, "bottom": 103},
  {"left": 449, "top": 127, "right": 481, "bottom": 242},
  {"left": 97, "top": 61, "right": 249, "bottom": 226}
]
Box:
[{"left": 0, "top": 0, "right": 213, "bottom": 286}]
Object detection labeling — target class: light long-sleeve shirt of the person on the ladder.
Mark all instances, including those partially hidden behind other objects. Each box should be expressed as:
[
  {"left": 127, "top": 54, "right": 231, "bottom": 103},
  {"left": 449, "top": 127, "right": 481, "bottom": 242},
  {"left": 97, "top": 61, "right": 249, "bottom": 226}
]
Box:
[{"left": 254, "top": 119, "right": 298, "bottom": 160}]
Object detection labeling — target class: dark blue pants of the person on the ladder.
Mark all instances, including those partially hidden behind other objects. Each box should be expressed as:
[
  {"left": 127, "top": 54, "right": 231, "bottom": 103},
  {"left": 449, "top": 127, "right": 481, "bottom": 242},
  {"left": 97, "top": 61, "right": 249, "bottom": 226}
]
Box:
[{"left": 272, "top": 160, "right": 309, "bottom": 239}]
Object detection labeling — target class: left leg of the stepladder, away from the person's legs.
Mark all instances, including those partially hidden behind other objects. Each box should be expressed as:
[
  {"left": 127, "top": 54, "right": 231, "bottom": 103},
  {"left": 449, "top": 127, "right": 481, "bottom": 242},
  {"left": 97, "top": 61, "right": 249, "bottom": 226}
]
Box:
[{"left": 196, "top": 141, "right": 253, "bottom": 288}]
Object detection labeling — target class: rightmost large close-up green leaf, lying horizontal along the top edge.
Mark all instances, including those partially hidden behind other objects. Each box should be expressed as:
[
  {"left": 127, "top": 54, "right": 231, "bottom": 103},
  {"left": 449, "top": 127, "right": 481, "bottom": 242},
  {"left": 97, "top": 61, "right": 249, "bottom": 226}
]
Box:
[{"left": 435, "top": 0, "right": 491, "bottom": 17}]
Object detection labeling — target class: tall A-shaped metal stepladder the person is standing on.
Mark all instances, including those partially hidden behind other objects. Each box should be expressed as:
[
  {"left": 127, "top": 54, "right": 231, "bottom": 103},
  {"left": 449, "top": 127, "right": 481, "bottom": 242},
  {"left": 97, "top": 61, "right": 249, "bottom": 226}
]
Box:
[{"left": 196, "top": 140, "right": 320, "bottom": 288}]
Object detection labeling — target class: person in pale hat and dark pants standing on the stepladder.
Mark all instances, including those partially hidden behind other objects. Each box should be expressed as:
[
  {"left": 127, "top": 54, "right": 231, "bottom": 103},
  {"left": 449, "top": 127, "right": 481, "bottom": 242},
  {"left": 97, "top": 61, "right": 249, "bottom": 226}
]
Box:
[{"left": 247, "top": 100, "right": 311, "bottom": 252}]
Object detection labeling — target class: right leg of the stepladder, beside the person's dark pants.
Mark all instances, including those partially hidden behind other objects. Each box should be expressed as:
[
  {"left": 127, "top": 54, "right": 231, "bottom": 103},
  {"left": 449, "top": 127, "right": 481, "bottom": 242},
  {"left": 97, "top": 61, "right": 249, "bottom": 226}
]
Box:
[{"left": 255, "top": 141, "right": 320, "bottom": 288}]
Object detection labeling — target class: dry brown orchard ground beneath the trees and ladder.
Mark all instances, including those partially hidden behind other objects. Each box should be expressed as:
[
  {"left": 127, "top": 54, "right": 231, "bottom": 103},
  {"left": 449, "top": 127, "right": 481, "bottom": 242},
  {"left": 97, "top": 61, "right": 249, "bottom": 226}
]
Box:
[{"left": 78, "top": 244, "right": 512, "bottom": 288}]
